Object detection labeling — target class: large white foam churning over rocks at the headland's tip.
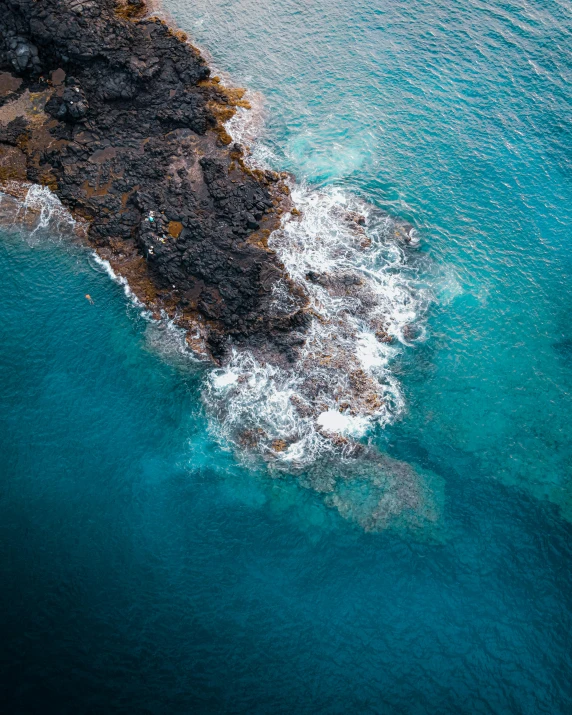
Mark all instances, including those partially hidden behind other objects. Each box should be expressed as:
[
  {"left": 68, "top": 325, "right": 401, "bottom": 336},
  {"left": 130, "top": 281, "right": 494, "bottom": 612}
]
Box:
[{"left": 204, "top": 109, "right": 432, "bottom": 470}]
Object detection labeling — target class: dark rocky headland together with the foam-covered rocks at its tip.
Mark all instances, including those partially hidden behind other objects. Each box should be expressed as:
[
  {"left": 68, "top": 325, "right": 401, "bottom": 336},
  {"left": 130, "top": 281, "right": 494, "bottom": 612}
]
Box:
[{"left": 0, "top": 0, "right": 428, "bottom": 476}]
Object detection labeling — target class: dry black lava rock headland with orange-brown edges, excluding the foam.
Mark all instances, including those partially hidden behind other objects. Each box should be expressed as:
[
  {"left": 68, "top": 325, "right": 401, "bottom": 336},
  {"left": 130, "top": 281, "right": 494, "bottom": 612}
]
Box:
[{"left": 0, "top": 0, "right": 308, "bottom": 364}]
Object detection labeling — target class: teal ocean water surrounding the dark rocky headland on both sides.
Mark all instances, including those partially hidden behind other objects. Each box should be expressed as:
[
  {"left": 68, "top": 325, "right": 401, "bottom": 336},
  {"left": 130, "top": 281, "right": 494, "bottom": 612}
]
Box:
[{"left": 0, "top": 0, "right": 572, "bottom": 715}]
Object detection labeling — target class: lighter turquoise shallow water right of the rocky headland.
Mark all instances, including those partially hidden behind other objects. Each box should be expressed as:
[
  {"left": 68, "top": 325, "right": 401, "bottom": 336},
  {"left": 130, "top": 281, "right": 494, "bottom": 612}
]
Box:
[{"left": 173, "top": 0, "right": 572, "bottom": 512}]
